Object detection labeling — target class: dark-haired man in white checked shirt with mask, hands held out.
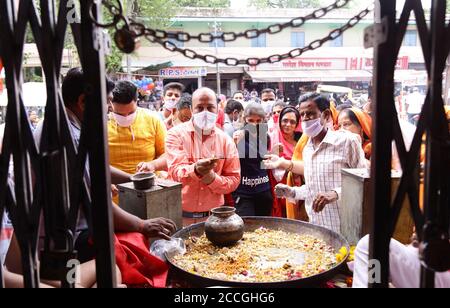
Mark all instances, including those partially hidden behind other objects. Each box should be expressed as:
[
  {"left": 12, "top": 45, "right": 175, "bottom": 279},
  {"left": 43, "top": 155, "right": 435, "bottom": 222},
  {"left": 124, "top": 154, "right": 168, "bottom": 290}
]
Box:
[{"left": 266, "top": 93, "right": 367, "bottom": 233}]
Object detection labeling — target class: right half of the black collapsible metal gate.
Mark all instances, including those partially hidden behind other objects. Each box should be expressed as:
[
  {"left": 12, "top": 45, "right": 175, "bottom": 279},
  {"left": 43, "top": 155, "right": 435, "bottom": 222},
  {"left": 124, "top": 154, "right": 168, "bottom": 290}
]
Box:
[{"left": 370, "top": 0, "right": 450, "bottom": 288}]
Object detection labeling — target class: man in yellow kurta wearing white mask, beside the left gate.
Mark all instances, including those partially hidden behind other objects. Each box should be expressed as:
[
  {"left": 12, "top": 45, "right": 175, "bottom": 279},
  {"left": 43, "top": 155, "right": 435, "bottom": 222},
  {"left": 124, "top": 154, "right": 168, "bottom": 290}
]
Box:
[{"left": 108, "top": 81, "right": 166, "bottom": 174}]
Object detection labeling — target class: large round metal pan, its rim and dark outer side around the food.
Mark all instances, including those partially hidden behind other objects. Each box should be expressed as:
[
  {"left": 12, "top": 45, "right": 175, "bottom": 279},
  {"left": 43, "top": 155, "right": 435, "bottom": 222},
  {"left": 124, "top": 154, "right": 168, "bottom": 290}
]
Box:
[{"left": 166, "top": 217, "right": 349, "bottom": 288}]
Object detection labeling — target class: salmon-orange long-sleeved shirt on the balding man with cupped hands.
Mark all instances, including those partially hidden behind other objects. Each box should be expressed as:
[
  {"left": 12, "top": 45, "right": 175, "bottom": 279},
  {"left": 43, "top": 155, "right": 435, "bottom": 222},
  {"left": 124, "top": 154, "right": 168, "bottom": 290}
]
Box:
[{"left": 166, "top": 121, "right": 241, "bottom": 212}]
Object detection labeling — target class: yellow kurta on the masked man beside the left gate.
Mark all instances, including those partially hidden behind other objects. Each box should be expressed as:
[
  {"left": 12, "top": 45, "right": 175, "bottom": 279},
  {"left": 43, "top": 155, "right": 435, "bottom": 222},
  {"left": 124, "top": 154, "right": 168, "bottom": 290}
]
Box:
[{"left": 108, "top": 108, "right": 166, "bottom": 174}]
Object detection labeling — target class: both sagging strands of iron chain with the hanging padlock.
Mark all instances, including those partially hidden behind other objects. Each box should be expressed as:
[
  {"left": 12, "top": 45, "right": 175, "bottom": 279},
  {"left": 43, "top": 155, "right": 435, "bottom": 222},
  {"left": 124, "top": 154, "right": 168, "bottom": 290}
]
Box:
[{"left": 91, "top": 0, "right": 372, "bottom": 66}]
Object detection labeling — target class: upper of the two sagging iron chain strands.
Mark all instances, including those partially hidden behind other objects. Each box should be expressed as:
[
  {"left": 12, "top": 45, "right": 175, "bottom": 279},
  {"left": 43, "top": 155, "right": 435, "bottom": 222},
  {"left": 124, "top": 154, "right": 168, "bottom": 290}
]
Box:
[{"left": 96, "top": 0, "right": 351, "bottom": 43}]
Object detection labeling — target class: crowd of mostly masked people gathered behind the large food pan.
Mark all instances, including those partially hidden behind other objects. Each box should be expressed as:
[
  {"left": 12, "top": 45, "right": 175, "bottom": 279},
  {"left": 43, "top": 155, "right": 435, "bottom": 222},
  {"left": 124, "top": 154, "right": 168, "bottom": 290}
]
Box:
[{"left": 0, "top": 68, "right": 450, "bottom": 283}]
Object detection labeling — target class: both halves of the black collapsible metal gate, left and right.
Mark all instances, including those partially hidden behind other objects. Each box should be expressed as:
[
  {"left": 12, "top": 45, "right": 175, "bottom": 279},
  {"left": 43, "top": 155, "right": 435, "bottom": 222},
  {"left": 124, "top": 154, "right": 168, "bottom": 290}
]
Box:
[{"left": 0, "top": 0, "right": 450, "bottom": 288}]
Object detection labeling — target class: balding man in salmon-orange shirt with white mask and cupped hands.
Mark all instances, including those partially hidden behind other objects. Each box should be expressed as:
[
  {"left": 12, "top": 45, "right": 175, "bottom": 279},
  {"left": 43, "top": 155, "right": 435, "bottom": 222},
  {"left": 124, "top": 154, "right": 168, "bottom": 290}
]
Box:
[{"left": 166, "top": 88, "right": 241, "bottom": 226}]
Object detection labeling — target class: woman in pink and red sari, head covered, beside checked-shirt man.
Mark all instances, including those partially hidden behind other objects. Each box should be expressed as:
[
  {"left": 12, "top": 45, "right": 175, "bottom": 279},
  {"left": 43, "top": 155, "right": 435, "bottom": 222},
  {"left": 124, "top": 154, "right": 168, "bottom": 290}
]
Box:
[{"left": 270, "top": 106, "right": 302, "bottom": 217}]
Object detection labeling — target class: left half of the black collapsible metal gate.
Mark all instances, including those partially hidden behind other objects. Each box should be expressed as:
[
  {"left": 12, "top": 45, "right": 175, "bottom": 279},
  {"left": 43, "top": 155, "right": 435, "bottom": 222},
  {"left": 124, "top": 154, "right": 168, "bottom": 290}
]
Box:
[{"left": 0, "top": 0, "right": 116, "bottom": 288}]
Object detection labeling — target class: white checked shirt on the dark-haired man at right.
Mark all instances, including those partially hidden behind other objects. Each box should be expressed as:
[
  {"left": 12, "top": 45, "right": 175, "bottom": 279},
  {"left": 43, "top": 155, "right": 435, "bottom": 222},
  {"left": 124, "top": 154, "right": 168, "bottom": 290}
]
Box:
[{"left": 294, "top": 130, "right": 367, "bottom": 233}]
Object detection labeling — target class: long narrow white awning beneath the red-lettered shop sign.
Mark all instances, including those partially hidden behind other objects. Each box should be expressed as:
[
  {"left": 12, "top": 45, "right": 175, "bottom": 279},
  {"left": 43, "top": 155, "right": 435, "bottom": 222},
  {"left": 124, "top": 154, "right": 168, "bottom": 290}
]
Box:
[{"left": 246, "top": 70, "right": 372, "bottom": 82}]
